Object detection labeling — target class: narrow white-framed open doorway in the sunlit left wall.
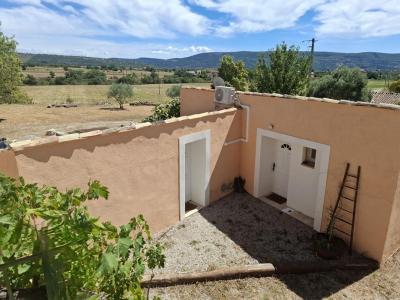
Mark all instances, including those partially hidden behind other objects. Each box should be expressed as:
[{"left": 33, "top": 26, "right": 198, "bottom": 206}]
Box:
[{"left": 179, "top": 130, "right": 210, "bottom": 220}]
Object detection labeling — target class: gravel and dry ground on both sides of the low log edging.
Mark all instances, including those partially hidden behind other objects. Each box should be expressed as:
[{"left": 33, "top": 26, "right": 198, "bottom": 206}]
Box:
[{"left": 149, "top": 194, "right": 400, "bottom": 299}]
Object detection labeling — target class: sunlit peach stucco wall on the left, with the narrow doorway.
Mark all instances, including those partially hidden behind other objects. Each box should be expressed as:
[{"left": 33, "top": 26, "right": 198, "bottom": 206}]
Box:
[{"left": 1, "top": 109, "right": 241, "bottom": 231}]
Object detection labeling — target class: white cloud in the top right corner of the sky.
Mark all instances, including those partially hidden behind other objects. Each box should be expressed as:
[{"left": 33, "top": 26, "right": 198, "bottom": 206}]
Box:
[{"left": 315, "top": 0, "right": 400, "bottom": 37}]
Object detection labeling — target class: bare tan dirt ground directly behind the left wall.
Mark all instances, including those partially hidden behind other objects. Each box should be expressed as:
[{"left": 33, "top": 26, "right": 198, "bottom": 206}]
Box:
[{"left": 0, "top": 104, "right": 153, "bottom": 141}]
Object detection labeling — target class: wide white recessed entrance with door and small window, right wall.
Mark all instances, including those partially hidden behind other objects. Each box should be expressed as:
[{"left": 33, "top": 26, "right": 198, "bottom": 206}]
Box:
[{"left": 254, "top": 128, "right": 330, "bottom": 231}]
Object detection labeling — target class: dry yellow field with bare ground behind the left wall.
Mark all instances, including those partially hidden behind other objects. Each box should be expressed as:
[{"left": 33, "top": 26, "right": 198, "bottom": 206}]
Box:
[{"left": 0, "top": 84, "right": 209, "bottom": 140}]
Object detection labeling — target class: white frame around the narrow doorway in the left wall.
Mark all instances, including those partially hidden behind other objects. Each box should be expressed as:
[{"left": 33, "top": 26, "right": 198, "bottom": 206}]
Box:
[{"left": 179, "top": 129, "right": 211, "bottom": 220}]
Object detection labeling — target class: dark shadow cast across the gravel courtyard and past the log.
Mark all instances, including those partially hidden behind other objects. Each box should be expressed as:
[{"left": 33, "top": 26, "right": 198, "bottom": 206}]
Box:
[{"left": 200, "top": 193, "right": 373, "bottom": 299}]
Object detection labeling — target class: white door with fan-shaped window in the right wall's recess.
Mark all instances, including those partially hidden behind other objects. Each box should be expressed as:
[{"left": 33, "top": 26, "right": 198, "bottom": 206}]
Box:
[{"left": 272, "top": 143, "right": 292, "bottom": 198}]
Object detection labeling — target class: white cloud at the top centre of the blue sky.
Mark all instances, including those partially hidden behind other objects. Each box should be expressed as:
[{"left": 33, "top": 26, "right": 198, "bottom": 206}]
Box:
[{"left": 191, "top": 0, "right": 324, "bottom": 35}]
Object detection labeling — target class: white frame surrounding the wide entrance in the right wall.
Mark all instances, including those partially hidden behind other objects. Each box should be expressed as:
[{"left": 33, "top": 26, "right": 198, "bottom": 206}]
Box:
[{"left": 253, "top": 128, "right": 330, "bottom": 232}]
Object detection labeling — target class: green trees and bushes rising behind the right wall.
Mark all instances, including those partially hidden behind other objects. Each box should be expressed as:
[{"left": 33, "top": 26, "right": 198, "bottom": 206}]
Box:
[{"left": 218, "top": 43, "right": 400, "bottom": 101}]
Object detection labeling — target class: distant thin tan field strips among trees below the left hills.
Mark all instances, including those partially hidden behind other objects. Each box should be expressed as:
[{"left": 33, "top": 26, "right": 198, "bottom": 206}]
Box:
[{"left": 23, "top": 67, "right": 173, "bottom": 79}]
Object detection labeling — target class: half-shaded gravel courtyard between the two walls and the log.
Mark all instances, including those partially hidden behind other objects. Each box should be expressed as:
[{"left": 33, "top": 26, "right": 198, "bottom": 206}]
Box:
[{"left": 150, "top": 194, "right": 356, "bottom": 273}]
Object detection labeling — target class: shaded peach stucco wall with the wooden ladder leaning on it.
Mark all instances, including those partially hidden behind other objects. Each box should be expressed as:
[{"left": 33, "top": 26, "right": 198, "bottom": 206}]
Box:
[{"left": 182, "top": 89, "right": 400, "bottom": 261}]
